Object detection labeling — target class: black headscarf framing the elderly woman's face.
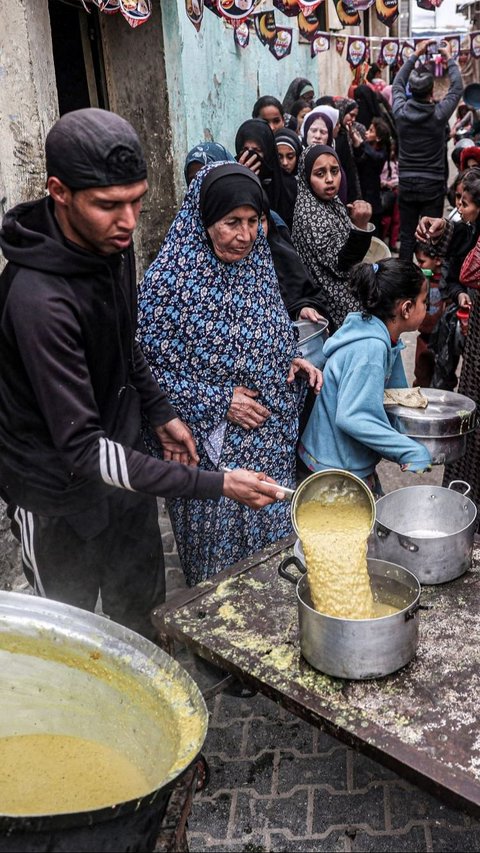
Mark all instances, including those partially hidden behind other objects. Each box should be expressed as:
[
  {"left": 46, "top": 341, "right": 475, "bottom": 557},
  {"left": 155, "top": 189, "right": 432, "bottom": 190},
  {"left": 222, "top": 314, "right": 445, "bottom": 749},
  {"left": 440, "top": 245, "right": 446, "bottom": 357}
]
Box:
[{"left": 200, "top": 163, "right": 263, "bottom": 228}]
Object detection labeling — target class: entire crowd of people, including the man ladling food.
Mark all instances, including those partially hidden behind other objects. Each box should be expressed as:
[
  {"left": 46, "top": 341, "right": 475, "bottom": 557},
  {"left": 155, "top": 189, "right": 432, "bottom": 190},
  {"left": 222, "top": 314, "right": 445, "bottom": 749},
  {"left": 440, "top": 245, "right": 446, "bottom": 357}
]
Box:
[{"left": 0, "top": 42, "right": 480, "bottom": 636}]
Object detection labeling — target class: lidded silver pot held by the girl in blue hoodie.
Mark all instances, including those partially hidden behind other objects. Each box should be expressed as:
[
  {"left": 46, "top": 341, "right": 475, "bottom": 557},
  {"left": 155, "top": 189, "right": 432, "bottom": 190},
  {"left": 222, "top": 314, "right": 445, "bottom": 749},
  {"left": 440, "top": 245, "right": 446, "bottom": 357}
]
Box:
[{"left": 385, "top": 388, "right": 477, "bottom": 465}]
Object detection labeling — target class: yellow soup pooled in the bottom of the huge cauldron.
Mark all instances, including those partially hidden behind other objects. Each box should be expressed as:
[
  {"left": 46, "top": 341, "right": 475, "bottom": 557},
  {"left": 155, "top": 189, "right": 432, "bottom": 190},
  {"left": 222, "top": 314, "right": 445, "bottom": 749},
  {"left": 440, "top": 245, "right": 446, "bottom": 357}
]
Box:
[{"left": 0, "top": 734, "right": 152, "bottom": 815}]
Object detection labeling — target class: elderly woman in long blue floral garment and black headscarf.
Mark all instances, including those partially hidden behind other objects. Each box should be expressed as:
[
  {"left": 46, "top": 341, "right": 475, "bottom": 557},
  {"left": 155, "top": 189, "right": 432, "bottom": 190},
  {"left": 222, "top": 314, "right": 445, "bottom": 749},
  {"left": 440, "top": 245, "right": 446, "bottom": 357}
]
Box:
[{"left": 139, "top": 164, "right": 321, "bottom": 586}]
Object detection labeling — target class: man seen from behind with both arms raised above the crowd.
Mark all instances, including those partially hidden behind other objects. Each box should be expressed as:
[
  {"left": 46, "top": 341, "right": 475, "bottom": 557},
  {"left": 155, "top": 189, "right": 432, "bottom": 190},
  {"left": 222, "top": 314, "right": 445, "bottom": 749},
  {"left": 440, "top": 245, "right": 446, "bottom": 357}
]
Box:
[{"left": 392, "top": 39, "right": 463, "bottom": 261}]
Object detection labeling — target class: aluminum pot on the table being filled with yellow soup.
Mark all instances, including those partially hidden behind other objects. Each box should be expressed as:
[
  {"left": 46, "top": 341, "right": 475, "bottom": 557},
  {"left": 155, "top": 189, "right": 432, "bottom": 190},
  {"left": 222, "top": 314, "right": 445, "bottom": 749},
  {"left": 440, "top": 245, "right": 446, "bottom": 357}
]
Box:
[{"left": 278, "top": 557, "right": 420, "bottom": 680}]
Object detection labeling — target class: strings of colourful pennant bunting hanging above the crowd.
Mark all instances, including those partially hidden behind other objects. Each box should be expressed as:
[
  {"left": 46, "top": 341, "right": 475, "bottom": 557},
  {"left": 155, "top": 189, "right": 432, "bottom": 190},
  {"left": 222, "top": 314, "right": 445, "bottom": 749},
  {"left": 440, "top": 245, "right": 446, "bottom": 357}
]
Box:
[{"left": 185, "top": 0, "right": 480, "bottom": 63}]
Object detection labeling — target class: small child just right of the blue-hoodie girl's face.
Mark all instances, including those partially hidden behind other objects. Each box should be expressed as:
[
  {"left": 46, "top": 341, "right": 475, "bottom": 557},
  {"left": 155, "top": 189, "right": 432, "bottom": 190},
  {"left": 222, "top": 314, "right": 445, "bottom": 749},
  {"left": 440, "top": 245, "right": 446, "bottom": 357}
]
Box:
[{"left": 413, "top": 242, "right": 445, "bottom": 388}]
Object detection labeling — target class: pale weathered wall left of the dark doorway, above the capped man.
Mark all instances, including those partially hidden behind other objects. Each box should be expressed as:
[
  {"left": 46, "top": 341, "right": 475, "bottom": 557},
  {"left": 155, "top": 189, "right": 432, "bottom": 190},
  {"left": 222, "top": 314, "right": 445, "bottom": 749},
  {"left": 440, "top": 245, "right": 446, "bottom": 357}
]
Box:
[{"left": 0, "top": 0, "right": 58, "bottom": 220}]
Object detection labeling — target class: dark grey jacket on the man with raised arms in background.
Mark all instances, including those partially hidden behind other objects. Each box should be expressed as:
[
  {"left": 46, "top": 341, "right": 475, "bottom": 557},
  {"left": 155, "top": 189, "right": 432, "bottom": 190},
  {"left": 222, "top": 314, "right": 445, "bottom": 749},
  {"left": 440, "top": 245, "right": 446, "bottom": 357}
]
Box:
[{"left": 392, "top": 56, "right": 463, "bottom": 182}]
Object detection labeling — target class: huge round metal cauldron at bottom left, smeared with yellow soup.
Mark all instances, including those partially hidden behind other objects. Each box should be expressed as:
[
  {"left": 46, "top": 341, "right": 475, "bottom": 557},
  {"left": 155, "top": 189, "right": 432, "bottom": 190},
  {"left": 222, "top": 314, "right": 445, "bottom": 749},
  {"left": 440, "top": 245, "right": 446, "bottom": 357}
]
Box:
[{"left": 0, "top": 592, "right": 207, "bottom": 851}]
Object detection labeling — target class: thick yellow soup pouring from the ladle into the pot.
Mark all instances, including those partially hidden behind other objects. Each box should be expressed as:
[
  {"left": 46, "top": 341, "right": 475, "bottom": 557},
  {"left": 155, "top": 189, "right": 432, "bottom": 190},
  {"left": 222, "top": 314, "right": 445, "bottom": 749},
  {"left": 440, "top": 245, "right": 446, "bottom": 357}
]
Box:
[{"left": 297, "top": 499, "right": 397, "bottom": 619}]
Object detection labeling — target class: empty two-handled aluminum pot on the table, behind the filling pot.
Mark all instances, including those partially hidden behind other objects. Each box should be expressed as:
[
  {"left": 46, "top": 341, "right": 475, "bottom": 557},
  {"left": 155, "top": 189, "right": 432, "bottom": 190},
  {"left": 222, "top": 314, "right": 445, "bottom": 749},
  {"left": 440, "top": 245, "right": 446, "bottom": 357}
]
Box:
[{"left": 371, "top": 480, "right": 477, "bottom": 584}]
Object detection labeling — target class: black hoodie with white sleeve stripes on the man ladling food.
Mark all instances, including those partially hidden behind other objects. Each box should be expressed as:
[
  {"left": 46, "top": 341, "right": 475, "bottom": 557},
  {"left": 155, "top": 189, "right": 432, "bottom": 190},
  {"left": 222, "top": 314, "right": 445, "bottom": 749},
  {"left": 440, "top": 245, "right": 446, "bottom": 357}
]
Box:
[{"left": 0, "top": 198, "right": 223, "bottom": 516}]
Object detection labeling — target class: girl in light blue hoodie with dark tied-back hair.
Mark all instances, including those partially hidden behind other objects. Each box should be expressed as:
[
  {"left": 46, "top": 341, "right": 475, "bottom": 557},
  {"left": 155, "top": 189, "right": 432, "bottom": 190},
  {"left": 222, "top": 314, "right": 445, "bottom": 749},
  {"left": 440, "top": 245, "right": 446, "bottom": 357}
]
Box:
[{"left": 299, "top": 258, "right": 431, "bottom": 493}]
